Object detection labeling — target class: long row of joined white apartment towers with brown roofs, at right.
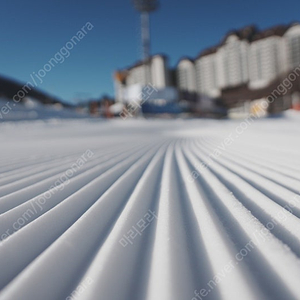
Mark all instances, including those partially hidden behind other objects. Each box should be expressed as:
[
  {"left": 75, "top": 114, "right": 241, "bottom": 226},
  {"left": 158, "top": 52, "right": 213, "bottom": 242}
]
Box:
[{"left": 184, "top": 23, "right": 300, "bottom": 106}]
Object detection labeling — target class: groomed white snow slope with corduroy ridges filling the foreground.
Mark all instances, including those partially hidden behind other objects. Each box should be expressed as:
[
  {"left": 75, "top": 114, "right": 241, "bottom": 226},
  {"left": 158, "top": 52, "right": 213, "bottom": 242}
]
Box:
[{"left": 0, "top": 113, "right": 300, "bottom": 300}]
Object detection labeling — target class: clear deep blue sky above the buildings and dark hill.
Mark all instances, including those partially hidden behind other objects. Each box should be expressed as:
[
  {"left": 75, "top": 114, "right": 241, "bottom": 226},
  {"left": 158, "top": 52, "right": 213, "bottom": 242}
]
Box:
[{"left": 0, "top": 0, "right": 300, "bottom": 102}]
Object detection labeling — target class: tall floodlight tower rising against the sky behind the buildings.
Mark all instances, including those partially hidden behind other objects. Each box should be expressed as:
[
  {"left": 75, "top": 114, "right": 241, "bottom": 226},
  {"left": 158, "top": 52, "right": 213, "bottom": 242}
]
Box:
[{"left": 132, "top": 0, "right": 158, "bottom": 84}]
